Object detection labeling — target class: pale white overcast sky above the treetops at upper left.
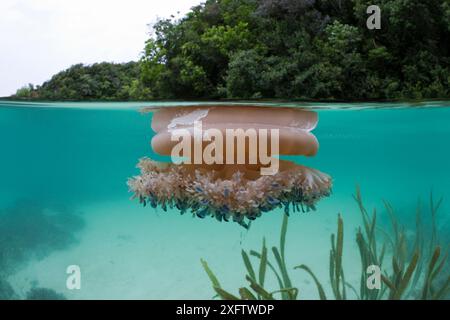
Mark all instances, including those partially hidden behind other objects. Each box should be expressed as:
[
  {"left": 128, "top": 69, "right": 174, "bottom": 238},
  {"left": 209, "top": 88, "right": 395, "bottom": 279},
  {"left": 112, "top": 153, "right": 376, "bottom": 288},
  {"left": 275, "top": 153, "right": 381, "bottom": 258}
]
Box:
[{"left": 0, "top": 0, "right": 203, "bottom": 97}]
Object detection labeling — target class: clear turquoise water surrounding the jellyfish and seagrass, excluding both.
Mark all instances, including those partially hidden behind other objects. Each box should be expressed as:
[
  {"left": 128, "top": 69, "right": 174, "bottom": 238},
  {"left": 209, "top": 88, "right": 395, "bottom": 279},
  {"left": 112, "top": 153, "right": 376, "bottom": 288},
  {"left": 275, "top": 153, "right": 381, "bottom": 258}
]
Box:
[{"left": 0, "top": 102, "right": 450, "bottom": 299}]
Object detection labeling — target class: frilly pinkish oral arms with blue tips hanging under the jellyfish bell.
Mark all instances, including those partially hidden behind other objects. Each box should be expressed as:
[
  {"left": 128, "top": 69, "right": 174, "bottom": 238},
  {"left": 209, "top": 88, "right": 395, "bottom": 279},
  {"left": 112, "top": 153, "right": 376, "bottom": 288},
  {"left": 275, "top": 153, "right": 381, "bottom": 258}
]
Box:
[{"left": 128, "top": 159, "right": 332, "bottom": 225}]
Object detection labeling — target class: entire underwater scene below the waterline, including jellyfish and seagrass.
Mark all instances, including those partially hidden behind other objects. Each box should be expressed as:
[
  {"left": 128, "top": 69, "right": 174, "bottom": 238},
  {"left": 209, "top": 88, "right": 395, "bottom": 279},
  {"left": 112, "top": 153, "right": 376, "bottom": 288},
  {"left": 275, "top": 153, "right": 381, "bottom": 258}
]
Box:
[{"left": 0, "top": 101, "right": 450, "bottom": 300}]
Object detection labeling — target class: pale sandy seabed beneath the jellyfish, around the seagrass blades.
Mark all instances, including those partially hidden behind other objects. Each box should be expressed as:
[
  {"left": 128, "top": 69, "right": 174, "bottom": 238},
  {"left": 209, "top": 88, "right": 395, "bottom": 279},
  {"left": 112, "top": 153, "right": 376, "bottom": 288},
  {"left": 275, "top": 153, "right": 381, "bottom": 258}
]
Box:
[{"left": 9, "top": 195, "right": 360, "bottom": 299}]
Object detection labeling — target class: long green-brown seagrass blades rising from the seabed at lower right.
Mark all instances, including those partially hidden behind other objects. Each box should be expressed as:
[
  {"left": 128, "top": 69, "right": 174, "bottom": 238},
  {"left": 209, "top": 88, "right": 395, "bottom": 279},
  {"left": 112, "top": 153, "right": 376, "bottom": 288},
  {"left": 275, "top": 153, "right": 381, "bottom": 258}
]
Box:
[{"left": 202, "top": 188, "right": 450, "bottom": 300}]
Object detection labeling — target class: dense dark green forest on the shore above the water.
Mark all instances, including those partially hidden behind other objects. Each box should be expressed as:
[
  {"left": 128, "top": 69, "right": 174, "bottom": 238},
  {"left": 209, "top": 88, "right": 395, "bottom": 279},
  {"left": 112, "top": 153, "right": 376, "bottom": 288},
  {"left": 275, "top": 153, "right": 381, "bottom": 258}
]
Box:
[{"left": 12, "top": 0, "right": 450, "bottom": 100}]
